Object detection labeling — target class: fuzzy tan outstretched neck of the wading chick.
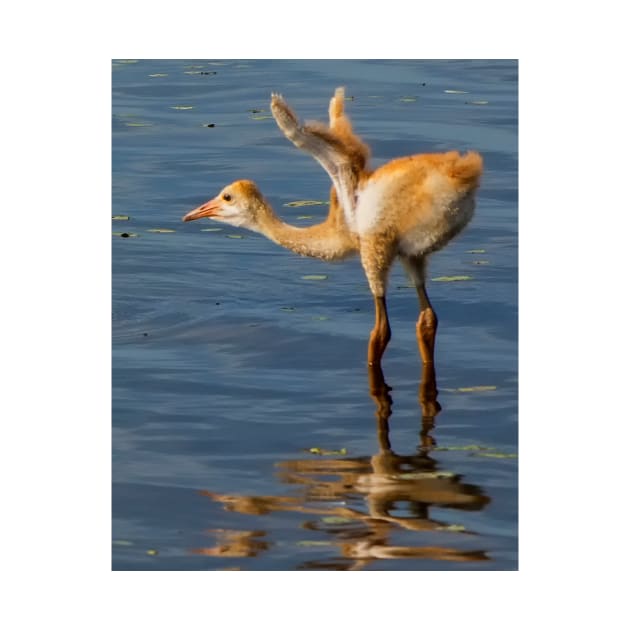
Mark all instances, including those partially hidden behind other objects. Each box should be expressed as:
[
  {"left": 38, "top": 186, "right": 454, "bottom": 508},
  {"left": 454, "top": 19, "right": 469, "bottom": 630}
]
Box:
[{"left": 256, "top": 196, "right": 358, "bottom": 260}]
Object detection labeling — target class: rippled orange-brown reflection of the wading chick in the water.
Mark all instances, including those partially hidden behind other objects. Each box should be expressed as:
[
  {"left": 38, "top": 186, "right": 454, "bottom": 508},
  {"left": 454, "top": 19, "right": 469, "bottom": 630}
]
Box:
[{"left": 193, "top": 364, "right": 490, "bottom": 570}]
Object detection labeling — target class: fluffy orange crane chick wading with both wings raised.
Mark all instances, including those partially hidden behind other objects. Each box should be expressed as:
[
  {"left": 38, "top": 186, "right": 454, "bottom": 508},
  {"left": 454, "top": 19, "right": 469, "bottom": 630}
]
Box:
[{"left": 183, "top": 89, "right": 483, "bottom": 365}]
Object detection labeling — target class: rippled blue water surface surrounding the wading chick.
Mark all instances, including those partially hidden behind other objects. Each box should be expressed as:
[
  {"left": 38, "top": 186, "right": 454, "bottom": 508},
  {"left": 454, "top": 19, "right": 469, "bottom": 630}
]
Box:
[{"left": 112, "top": 60, "right": 518, "bottom": 571}]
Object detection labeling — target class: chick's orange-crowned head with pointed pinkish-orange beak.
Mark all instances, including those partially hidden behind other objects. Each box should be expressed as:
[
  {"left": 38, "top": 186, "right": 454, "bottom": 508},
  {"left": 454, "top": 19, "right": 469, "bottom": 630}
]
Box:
[{"left": 182, "top": 179, "right": 266, "bottom": 230}]
